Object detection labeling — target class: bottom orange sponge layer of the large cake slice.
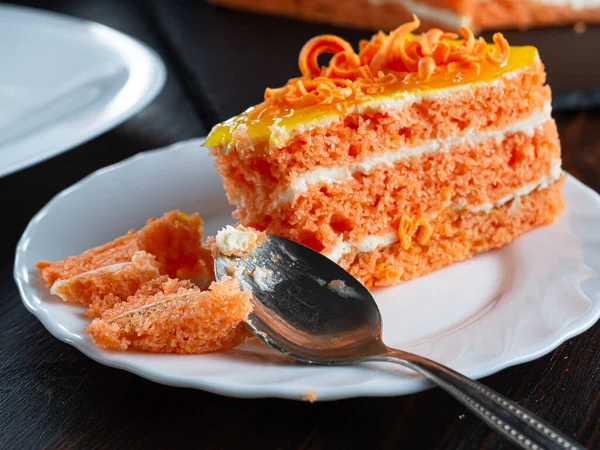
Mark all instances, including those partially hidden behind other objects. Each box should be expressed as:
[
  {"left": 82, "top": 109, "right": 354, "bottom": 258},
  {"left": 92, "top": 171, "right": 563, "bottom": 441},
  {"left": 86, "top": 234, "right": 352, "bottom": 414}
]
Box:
[{"left": 339, "top": 177, "right": 564, "bottom": 287}]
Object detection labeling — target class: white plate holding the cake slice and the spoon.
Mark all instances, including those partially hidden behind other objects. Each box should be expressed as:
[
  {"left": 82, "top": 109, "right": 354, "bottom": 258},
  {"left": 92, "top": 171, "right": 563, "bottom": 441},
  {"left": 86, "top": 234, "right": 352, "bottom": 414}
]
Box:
[{"left": 15, "top": 140, "right": 600, "bottom": 400}]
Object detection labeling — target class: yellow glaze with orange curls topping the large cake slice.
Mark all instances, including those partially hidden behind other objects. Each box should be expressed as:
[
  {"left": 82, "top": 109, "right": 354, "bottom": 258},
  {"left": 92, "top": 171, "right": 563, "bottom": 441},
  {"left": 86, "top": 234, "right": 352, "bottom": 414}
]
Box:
[{"left": 206, "top": 16, "right": 537, "bottom": 147}]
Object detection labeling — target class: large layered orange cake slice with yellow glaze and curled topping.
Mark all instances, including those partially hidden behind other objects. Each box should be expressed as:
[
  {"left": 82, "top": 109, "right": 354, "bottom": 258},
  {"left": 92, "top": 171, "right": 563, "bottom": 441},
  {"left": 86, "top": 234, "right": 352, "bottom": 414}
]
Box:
[{"left": 206, "top": 17, "right": 564, "bottom": 287}]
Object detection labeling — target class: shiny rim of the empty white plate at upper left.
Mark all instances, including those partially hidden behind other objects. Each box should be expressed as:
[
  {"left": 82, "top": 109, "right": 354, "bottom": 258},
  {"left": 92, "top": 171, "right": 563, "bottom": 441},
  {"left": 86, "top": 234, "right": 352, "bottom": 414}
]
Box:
[{"left": 0, "top": 4, "right": 167, "bottom": 178}]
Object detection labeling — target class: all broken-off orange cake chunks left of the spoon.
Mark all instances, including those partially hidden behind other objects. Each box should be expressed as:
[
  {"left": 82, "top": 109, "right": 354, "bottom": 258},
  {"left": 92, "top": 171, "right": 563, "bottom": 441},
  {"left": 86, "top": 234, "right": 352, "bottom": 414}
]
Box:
[{"left": 36, "top": 210, "right": 260, "bottom": 354}]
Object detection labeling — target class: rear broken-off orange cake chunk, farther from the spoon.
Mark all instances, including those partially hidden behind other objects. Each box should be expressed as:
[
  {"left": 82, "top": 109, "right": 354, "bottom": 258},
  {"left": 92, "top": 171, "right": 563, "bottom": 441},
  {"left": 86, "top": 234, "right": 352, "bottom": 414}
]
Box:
[{"left": 36, "top": 211, "right": 214, "bottom": 306}]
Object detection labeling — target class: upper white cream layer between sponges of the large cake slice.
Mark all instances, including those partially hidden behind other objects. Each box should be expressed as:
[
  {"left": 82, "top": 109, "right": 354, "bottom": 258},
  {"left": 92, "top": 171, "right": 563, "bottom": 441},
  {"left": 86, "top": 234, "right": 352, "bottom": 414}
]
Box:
[{"left": 276, "top": 102, "right": 552, "bottom": 204}]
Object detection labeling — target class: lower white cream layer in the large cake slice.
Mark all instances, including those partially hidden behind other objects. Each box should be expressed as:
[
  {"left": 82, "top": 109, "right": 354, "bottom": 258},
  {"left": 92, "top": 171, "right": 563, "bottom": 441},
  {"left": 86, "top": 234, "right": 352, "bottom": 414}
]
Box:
[{"left": 325, "top": 159, "right": 561, "bottom": 262}]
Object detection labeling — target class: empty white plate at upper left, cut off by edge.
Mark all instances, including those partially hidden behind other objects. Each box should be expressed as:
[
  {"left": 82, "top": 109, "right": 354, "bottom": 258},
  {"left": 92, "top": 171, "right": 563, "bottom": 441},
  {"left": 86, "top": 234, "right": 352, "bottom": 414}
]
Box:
[{"left": 0, "top": 5, "right": 166, "bottom": 176}]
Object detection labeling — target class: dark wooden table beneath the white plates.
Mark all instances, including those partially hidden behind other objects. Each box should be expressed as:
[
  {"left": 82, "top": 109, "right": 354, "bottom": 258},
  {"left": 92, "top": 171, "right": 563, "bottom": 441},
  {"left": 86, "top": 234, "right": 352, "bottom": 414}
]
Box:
[{"left": 0, "top": 0, "right": 600, "bottom": 449}]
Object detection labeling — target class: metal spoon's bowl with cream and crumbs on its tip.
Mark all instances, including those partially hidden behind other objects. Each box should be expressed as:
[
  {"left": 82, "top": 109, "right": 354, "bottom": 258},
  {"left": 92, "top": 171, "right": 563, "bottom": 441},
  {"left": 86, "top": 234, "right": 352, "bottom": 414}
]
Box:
[{"left": 215, "top": 236, "right": 386, "bottom": 364}]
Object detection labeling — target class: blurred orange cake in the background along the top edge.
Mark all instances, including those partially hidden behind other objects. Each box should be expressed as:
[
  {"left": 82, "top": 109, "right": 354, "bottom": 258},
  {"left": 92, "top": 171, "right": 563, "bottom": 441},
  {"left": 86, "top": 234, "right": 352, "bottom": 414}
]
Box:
[{"left": 210, "top": 0, "right": 600, "bottom": 31}]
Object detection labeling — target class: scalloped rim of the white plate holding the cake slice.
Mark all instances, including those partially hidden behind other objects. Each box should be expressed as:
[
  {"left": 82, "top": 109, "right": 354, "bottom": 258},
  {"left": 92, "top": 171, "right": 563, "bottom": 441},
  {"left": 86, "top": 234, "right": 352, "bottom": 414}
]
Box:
[{"left": 13, "top": 137, "right": 600, "bottom": 401}]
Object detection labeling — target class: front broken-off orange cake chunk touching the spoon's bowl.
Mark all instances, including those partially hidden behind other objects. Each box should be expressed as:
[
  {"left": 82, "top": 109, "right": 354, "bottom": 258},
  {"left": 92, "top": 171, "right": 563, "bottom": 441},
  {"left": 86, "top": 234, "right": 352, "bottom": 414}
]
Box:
[{"left": 86, "top": 276, "right": 252, "bottom": 354}]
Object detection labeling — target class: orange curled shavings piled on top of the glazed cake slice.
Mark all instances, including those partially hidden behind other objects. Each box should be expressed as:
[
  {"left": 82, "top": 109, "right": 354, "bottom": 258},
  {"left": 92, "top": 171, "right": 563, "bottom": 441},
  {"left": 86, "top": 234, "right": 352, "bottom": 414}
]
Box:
[{"left": 249, "top": 16, "right": 510, "bottom": 119}]
